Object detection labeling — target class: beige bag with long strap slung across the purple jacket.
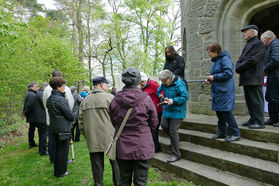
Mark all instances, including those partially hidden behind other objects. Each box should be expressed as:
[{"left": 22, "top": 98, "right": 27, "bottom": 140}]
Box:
[{"left": 106, "top": 107, "right": 133, "bottom": 160}]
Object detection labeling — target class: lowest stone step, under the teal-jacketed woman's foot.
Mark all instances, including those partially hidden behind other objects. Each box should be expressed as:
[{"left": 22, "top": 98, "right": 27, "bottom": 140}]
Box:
[{"left": 151, "top": 153, "right": 267, "bottom": 186}]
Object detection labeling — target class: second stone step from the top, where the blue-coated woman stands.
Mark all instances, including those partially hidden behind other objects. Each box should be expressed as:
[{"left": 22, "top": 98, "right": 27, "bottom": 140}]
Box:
[{"left": 160, "top": 129, "right": 279, "bottom": 162}]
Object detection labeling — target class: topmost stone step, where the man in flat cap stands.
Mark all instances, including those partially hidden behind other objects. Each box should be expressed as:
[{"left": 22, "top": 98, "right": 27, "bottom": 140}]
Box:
[{"left": 181, "top": 114, "right": 279, "bottom": 144}]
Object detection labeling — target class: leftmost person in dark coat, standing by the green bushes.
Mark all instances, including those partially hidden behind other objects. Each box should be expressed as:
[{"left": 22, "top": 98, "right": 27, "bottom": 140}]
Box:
[{"left": 23, "top": 82, "right": 38, "bottom": 148}]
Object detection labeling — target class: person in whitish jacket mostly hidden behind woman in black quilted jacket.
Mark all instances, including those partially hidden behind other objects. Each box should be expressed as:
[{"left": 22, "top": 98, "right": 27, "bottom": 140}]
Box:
[{"left": 43, "top": 70, "right": 74, "bottom": 163}]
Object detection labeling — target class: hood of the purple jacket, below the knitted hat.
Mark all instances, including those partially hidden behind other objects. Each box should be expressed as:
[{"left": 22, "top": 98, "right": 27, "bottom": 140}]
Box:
[{"left": 114, "top": 86, "right": 147, "bottom": 108}]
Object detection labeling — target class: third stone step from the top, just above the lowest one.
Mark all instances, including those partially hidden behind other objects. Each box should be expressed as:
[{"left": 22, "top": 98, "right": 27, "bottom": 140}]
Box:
[{"left": 160, "top": 137, "right": 279, "bottom": 185}]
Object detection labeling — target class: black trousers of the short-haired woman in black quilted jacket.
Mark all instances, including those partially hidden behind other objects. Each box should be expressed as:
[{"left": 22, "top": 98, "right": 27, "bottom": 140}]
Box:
[{"left": 53, "top": 134, "right": 70, "bottom": 176}]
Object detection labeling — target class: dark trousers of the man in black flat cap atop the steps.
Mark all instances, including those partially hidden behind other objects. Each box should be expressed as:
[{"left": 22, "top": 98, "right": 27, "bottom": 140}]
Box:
[{"left": 243, "top": 85, "right": 264, "bottom": 125}]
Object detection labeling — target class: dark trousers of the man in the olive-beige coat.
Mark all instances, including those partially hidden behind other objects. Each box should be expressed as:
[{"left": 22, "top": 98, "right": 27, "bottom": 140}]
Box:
[{"left": 89, "top": 152, "right": 120, "bottom": 186}]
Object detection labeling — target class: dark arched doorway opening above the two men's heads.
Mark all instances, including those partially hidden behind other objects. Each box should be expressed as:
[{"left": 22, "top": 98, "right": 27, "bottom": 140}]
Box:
[{"left": 249, "top": 5, "right": 279, "bottom": 38}]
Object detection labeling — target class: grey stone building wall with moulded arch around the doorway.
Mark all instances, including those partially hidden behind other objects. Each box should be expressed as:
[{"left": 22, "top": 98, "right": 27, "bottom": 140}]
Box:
[{"left": 181, "top": 0, "right": 279, "bottom": 115}]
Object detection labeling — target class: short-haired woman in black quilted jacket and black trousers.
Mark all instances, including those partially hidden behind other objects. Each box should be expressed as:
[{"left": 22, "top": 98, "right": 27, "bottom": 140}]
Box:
[{"left": 47, "top": 77, "right": 74, "bottom": 177}]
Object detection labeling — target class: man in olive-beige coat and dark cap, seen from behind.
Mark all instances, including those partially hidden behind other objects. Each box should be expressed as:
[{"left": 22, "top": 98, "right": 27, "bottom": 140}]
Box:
[{"left": 79, "top": 77, "right": 120, "bottom": 186}]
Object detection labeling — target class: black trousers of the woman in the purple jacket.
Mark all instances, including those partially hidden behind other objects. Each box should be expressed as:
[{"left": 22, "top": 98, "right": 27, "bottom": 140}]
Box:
[{"left": 117, "top": 159, "right": 151, "bottom": 186}]
